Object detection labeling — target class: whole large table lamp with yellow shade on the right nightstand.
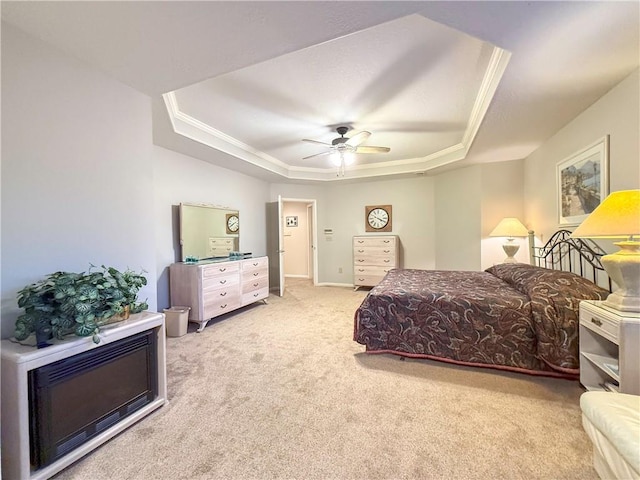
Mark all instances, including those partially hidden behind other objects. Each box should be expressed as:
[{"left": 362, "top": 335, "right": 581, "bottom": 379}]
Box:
[{"left": 571, "top": 190, "right": 640, "bottom": 312}]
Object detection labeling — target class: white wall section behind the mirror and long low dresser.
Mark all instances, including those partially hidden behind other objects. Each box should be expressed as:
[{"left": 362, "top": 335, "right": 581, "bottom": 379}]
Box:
[{"left": 152, "top": 146, "right": 269, "bottom": 309}]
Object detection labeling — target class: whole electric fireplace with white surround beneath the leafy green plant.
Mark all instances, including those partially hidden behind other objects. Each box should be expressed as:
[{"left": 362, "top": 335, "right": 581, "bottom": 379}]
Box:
[{"left": 0, "top": 312, "right": 167, "bottom": 480}]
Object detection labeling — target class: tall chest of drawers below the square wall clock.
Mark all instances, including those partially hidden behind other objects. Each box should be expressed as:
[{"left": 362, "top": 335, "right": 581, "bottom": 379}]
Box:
[{"left": 353, "top": 235, "right": 400, "bottom": 290}]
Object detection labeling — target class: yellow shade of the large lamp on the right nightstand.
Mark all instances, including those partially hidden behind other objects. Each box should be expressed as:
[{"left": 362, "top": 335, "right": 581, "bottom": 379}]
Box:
[{"left": 571, "top": 190, "right": 640, "bottom": 238}]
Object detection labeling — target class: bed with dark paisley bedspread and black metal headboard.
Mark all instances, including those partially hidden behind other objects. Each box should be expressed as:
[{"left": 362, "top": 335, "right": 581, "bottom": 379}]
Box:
[{"left": 354, "top": 230, "right": 610, "bottom": 379}]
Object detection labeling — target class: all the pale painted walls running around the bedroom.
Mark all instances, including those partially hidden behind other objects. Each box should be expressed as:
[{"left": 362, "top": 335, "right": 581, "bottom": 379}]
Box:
[{"left": 1, "top": 24, "right": 640, "bottom": 337}]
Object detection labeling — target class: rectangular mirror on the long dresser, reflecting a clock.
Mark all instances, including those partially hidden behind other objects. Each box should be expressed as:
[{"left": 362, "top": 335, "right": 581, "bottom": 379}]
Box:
[{"left": 180, "top": 203, "right": 240, "bottom": 262}]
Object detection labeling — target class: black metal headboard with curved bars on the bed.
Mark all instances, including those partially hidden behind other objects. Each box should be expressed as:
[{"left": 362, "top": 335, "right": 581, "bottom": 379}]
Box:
[{"left": 529, "top": 230, "right": 612, "bottom": 291}]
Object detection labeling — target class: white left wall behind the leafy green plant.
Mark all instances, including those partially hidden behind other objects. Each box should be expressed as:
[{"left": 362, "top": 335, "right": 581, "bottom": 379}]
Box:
[{"left": 1, "top": 23, "right": 156, "bottom": 338}]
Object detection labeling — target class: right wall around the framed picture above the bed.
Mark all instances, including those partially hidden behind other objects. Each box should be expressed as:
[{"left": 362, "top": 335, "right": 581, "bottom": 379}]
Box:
[{"left": 525, "top": 70, "right": 640, "bottom": 242}]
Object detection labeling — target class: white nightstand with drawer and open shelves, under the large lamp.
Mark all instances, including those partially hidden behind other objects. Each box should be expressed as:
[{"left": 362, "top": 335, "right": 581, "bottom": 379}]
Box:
[{"left": 580, "top": 300, "right": 640, "bottom": 395}]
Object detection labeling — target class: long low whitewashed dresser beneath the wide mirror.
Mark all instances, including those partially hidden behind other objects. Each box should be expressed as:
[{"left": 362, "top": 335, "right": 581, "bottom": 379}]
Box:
[{"left": 169, "top": 257, "right": 269, "bottom": 332}]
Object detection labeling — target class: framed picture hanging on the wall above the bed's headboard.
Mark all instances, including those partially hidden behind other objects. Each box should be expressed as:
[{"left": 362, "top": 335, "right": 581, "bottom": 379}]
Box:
[{"left": 556, "top": 135, "right": 609, "bottom": 226}]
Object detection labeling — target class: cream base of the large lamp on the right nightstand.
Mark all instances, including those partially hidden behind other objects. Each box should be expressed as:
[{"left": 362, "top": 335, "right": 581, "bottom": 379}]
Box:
[{"left": 601, "top": 241, "right": 640, "bottom": 312}]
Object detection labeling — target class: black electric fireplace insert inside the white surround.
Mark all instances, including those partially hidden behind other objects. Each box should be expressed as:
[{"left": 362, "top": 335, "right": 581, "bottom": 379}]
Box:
[{"left": 29, "top": 331, "right": 158, "bottom": 469}]
